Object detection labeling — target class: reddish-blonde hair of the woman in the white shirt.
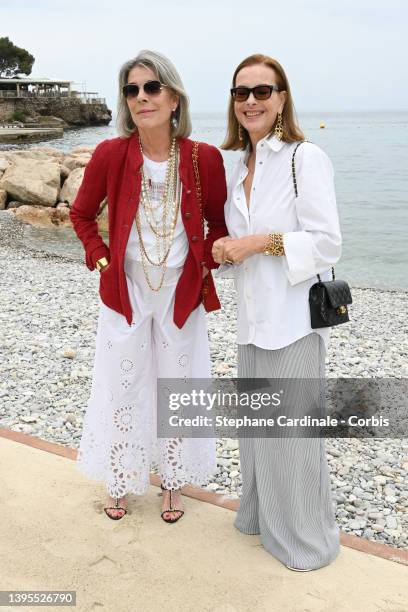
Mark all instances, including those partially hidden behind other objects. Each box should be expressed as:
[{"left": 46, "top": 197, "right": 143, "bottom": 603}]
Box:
[{"left": 221, "top": 53, "right": 304, "bottom": 151}]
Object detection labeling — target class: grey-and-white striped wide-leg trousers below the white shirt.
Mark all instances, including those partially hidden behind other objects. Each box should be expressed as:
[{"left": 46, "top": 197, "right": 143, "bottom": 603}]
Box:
[{"left": 234, "top": 333, "right": 340, "bottom": 569}]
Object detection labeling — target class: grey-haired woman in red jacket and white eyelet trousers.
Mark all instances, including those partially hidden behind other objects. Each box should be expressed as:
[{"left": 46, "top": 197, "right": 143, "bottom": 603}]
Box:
[{"left": 70, "top": 51, "right": 227, "bottom": 522}]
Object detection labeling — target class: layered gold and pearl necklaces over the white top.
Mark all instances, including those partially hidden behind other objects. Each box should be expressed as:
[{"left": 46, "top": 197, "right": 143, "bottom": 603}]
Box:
[{"left": 136, "top": 138, "right": 180, "bottom": 291}]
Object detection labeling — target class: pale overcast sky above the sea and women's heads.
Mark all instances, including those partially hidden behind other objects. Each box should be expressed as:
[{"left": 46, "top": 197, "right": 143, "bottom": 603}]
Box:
[{"left": 0, "top": 0, "right": 408, "bottom": 113}]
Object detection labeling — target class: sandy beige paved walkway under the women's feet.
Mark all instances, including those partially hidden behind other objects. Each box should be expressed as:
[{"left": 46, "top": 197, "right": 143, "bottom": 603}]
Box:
[{"left": 0, "top": 430, "right": 408, "bottom": 612}]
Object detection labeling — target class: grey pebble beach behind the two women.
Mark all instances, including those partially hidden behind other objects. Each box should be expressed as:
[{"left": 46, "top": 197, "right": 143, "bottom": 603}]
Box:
[{"left": 0, "top": 211, "right": 408, "bottom": 550}]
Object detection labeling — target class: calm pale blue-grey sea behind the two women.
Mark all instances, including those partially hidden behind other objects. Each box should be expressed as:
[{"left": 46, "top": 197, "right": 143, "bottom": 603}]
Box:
[{"left": 0, "top": 112, "right": 408, "bottom": 291}]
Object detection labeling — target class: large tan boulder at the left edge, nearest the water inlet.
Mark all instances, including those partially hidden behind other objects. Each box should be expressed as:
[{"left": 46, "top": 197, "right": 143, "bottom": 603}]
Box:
[{"left": 0, "top": 156, "right": 61, "bottom": 206}]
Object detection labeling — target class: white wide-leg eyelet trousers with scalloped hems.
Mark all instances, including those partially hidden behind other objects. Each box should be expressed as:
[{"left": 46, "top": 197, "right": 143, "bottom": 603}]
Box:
[{"left": 76, "top": 259, "right": 217, "bottom": 498}]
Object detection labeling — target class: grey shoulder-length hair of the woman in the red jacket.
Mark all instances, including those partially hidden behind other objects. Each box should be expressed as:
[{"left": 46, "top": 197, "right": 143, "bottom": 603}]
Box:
[{"left": 116, "top": 49, "right": 192, "bottom": 138}]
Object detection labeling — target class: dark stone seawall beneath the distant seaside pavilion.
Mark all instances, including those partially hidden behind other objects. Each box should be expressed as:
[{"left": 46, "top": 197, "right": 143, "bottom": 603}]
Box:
[{"left": 0, "top": 97, "right": 112, "bottom": 127}]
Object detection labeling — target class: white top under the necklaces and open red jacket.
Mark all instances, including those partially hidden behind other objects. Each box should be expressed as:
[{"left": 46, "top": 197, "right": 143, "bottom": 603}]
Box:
[{"left": 126, "top": 155, "right": 188, "bottom": 268}]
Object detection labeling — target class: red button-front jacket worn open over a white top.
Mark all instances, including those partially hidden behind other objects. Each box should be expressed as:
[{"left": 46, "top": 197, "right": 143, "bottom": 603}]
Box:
[{"left": 70, "top": 133, "right": 228, "bottom": 328}]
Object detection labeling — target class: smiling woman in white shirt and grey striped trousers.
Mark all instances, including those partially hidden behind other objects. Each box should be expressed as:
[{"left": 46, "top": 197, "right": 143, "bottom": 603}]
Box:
[{"left": 213, "top": 55, "right": 341, "bottom": 571}]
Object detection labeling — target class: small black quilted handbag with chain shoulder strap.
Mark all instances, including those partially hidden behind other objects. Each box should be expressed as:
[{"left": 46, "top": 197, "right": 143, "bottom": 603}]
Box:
[{"left": 292, "top": 142, "right": 353, "bottom": 329}]
